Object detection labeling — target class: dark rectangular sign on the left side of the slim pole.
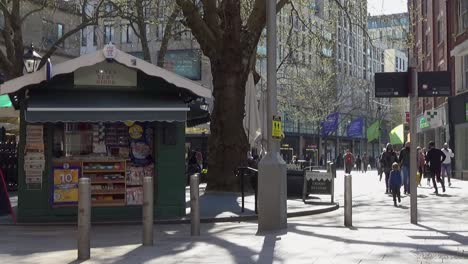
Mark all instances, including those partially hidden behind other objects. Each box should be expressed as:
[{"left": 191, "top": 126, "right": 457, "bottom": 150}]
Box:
[{"left": 375, "top": 72, "right": 410, "bottom": 98}]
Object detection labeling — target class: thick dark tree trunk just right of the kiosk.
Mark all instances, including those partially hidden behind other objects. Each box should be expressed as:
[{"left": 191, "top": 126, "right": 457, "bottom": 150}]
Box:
[{"left": 207, "top": 0, "right": 251, "bottom": 191}]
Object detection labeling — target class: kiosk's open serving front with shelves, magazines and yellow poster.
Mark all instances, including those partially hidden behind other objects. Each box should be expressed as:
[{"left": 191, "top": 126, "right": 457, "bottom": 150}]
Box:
[{"left": 52, "top": 122, "right": 154, "bottom": 206}]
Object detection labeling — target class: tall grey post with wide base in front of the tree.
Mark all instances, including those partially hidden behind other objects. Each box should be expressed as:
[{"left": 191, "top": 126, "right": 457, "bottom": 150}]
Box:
[{"left": 258, "top": 0, "right": 287, "bottom": 232}]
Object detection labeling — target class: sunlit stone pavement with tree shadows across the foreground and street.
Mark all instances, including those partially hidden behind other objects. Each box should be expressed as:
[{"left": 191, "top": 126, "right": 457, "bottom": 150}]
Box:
[{"left": 0, "top": 171, "right": 468, "bottom": 264}]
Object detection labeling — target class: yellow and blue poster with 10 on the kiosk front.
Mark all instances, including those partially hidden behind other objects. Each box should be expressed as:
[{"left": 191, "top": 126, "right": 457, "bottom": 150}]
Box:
[{"left": 53, "top": 168, "right": 80, "bottom": 205}]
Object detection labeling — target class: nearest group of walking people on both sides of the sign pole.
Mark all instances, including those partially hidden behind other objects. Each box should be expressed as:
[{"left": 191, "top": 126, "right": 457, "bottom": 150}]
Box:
[{"left": 379, "top": 141, "right": 455, "bottom": 206}]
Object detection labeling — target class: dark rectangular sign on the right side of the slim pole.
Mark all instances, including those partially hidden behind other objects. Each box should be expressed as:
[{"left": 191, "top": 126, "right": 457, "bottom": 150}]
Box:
[{"left": 418, "top": 71, "right": 452, "bottom": 97}]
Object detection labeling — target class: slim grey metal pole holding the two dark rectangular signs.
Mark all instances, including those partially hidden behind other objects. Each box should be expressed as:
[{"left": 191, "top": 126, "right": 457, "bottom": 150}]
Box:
[{"left": 410, "top": 67, "right": 418, "bottom": 224}]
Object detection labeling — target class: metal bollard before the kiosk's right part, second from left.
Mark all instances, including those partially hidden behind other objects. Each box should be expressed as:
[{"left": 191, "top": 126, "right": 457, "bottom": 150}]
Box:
[{"left": 143, "top": 176, "right": 154, "bottom": 246}]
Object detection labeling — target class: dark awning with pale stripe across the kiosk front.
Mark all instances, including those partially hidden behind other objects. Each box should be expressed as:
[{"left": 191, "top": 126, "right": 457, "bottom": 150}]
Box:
[{"left": 25, "top": 92, "right": 190, "bottom": 123}]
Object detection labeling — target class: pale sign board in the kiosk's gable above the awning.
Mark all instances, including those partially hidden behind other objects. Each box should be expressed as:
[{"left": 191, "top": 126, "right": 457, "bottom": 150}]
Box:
[{"left": 74, "top": 61, "right": 137, "bottom": 87}]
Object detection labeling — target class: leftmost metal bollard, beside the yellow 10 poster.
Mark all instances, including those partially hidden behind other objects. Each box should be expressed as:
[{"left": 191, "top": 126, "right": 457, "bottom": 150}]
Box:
[{"left": 78, "top": 178, "right": 91, "bottom": 260}]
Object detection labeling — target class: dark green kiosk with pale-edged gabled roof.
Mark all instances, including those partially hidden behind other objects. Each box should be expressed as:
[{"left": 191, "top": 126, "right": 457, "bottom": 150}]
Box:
[{"left": 0, "top": 45, "right": 211, "bottom": 222}]
